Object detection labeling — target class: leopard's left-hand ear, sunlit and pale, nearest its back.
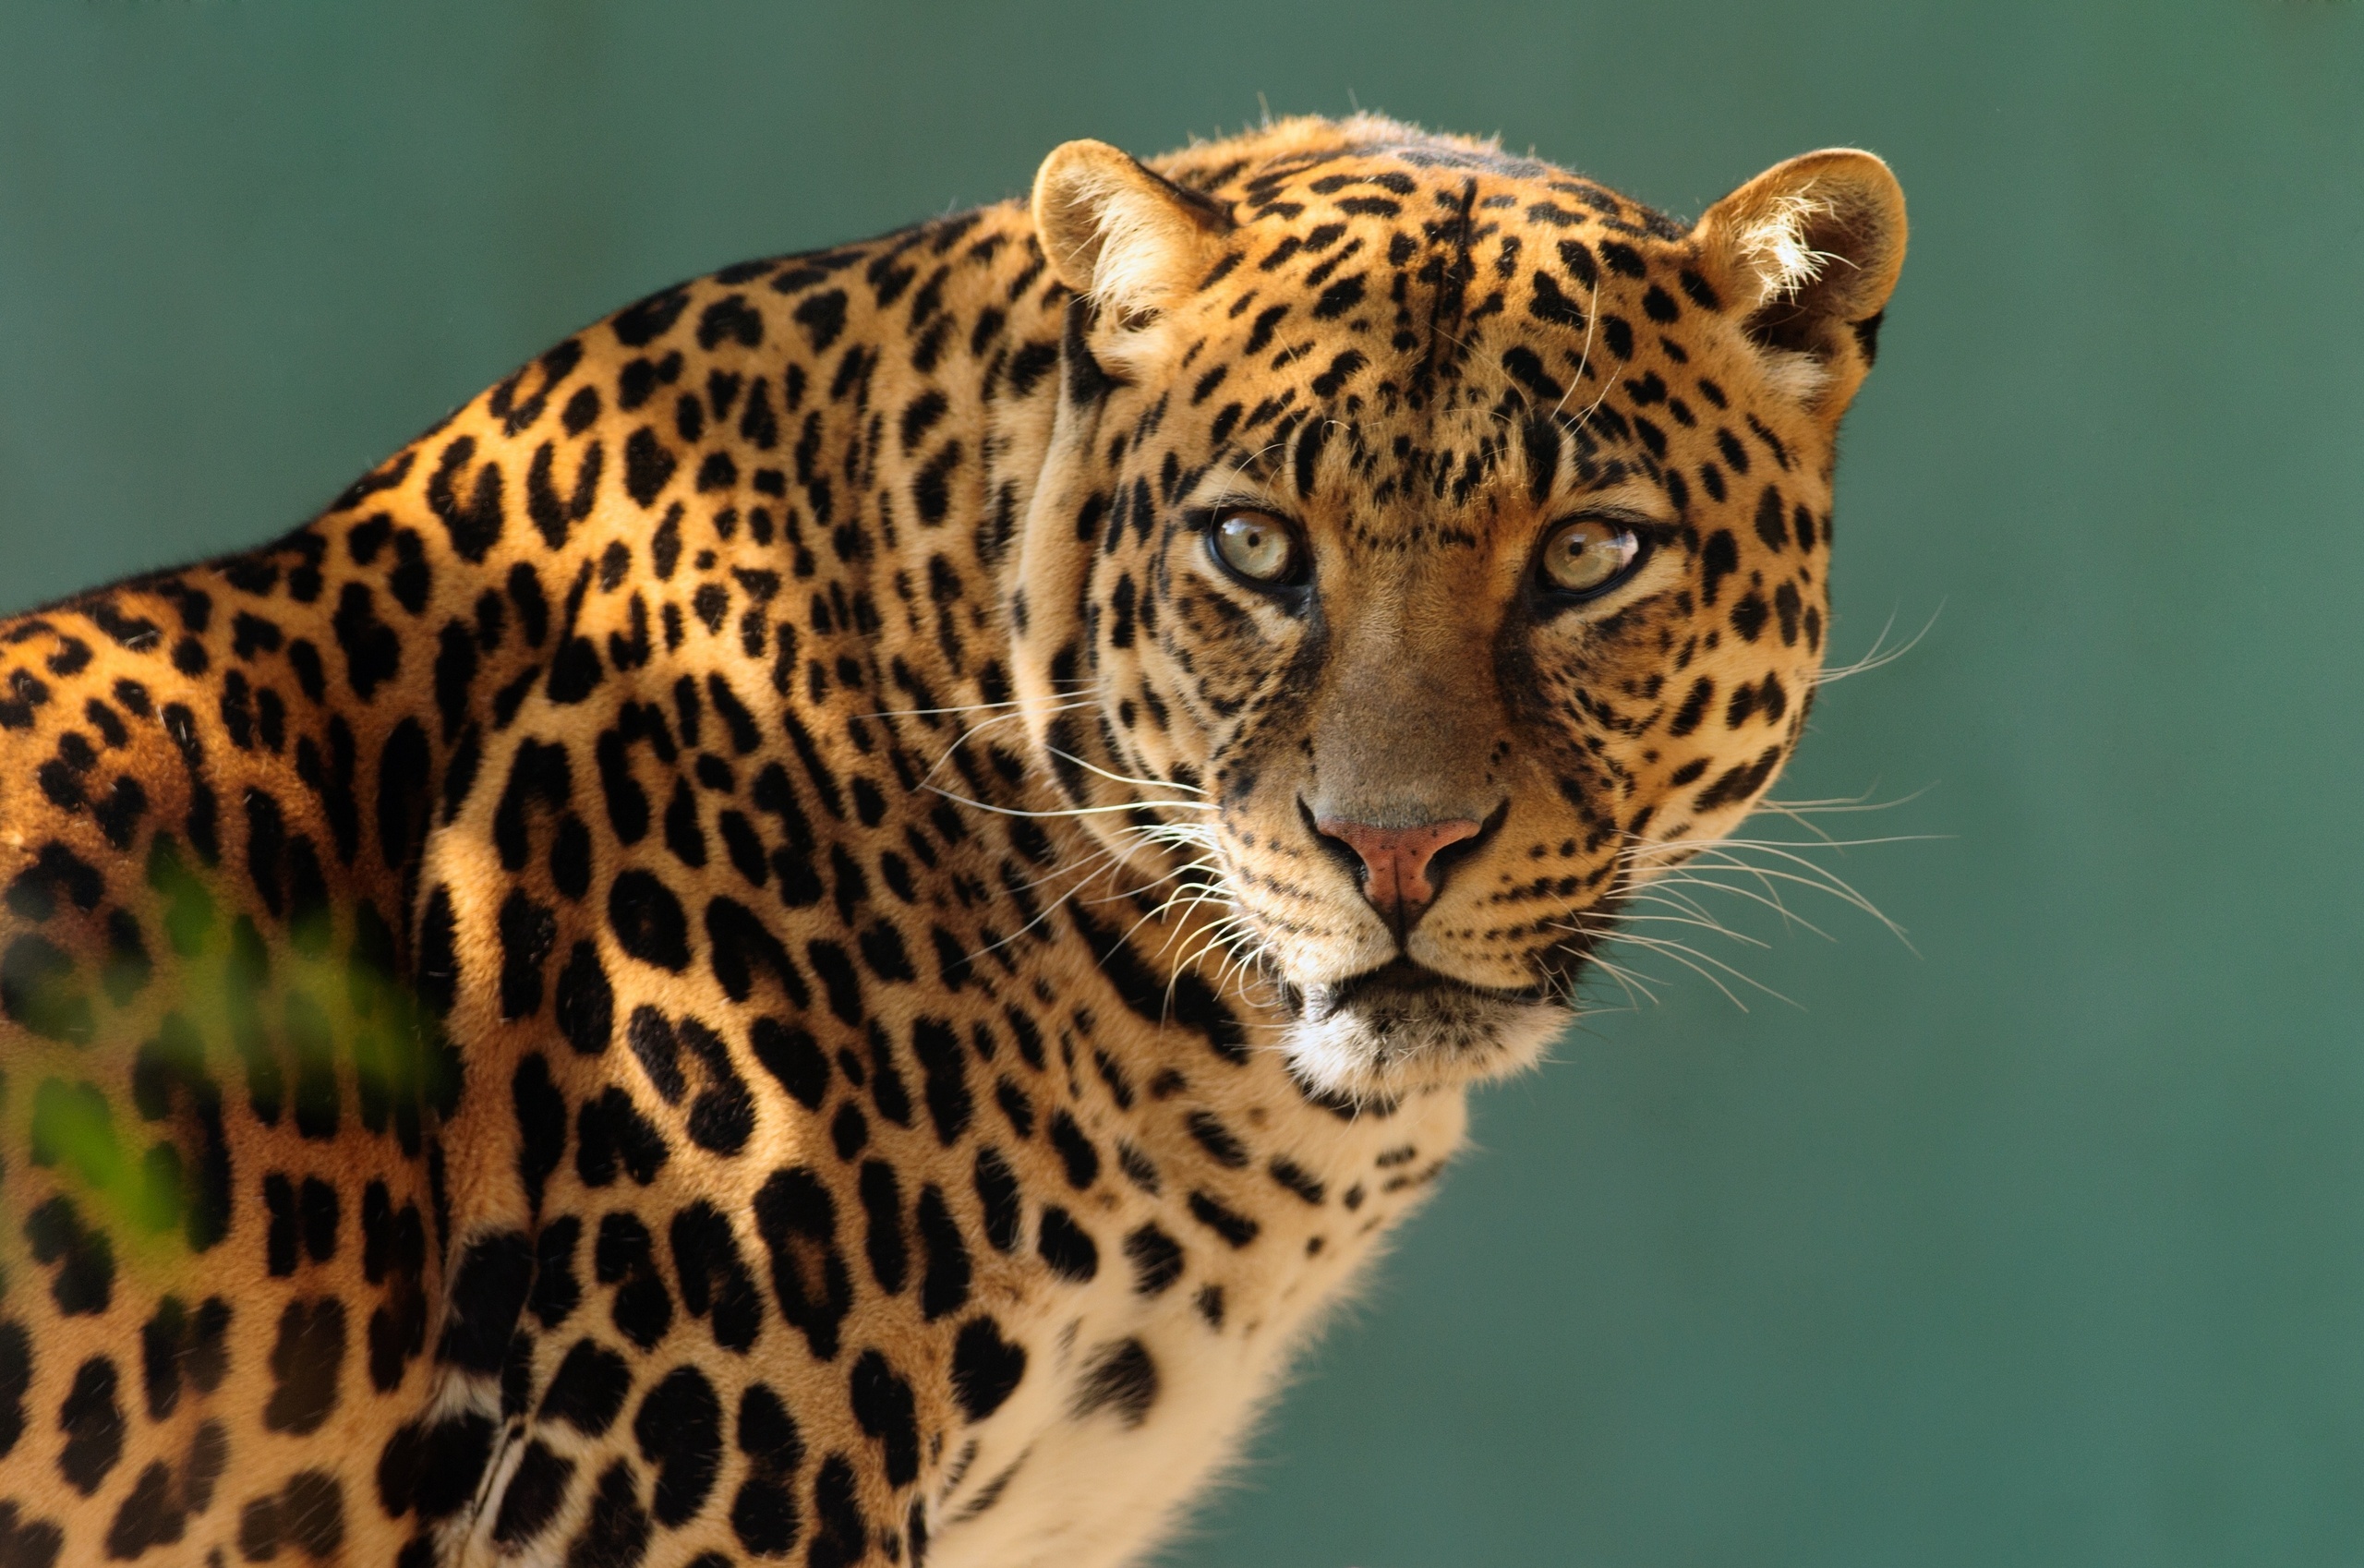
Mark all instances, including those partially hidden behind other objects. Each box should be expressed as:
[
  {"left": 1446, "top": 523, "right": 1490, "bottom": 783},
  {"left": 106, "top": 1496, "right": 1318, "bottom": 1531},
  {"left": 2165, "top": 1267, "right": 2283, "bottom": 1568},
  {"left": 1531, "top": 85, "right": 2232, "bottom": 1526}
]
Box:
[{"left": 1033, "top": 142, "right": 1232, "bottom": 321}]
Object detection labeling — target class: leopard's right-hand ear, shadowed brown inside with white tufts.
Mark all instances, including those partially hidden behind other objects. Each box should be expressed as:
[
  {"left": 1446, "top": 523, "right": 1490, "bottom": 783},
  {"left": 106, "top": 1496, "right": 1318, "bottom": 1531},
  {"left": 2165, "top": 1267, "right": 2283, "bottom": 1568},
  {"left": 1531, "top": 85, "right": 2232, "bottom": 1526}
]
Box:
[{"left": 1693, "top": 147, "right": 1905, "bottom": 418}]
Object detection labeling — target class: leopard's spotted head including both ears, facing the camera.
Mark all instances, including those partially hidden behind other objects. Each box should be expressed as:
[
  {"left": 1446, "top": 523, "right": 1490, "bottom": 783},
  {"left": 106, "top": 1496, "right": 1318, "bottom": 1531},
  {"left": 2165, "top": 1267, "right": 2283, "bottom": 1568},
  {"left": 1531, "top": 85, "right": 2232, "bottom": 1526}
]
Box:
[{"left": 1019, "top": 126, "right": 1903, "bottom": 1097}]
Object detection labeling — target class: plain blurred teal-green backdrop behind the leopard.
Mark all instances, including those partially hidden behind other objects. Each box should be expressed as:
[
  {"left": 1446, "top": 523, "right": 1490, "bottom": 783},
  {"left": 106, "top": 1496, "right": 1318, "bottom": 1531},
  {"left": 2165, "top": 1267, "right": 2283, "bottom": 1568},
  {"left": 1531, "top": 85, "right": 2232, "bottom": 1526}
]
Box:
[{"left": 0, "top": 0, "right": 2364, "bottom": 1568}]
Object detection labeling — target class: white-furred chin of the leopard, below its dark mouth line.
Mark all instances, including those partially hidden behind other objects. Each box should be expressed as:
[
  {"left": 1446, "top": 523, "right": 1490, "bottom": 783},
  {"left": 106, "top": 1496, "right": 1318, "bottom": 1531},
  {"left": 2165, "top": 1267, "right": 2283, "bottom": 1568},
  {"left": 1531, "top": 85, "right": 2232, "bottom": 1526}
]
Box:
[{"left": 1284, "top": 986, "right": 1574, "bottom": 1100}]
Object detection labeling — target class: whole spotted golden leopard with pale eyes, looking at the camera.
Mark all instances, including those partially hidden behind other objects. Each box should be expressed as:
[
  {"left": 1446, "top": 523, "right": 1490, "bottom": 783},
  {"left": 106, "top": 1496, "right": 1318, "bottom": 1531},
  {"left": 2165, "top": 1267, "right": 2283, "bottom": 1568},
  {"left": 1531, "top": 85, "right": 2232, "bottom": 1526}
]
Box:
[{"left": 0, "top": 114, "right": 1905, "bottom": 1568}]
